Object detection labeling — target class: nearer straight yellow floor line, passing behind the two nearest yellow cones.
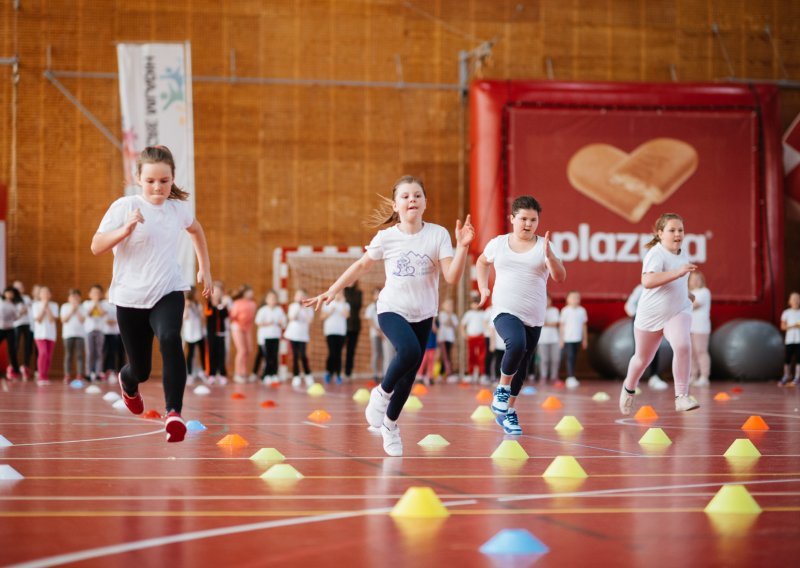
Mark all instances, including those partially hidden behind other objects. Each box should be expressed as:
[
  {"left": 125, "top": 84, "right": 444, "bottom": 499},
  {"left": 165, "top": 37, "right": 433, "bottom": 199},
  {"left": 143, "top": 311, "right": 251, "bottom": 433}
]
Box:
[{"left": 0, "top": 507, "right": 800, "bottom": 518}]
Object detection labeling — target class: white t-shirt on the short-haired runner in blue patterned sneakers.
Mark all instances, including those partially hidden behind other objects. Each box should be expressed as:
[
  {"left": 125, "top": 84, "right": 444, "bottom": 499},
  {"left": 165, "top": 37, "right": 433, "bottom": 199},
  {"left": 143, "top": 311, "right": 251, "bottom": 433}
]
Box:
[{"left": 483, "top": 234, "right": 550, "bottom": 327}]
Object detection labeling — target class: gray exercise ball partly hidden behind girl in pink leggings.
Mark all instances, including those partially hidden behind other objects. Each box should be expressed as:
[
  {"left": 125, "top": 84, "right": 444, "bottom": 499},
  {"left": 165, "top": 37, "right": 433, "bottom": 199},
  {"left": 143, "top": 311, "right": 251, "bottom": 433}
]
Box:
[{"left": 589, "top": 318, "right": 672, "bottom": 379}]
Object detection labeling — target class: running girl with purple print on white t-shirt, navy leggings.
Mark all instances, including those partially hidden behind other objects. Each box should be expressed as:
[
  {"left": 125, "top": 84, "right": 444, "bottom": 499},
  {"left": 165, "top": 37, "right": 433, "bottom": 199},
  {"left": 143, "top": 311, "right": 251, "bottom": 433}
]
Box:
[{"left": 304, "top": 176, "right": 475, "bottom": 456}]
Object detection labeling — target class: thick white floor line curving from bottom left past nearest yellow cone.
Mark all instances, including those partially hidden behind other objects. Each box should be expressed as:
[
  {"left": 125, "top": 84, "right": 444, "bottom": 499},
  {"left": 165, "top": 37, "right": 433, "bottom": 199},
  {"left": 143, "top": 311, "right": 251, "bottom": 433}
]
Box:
[{"left": 11, "top": 499, "right": 477, "bottom": 568}]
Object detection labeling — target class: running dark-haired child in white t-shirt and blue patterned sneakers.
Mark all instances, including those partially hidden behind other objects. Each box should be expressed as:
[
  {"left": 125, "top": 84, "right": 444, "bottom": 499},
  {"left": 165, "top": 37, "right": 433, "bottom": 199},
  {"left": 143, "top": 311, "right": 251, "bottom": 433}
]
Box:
[{"left": 475, "top": 195, "right": 567, "bottom": 434}]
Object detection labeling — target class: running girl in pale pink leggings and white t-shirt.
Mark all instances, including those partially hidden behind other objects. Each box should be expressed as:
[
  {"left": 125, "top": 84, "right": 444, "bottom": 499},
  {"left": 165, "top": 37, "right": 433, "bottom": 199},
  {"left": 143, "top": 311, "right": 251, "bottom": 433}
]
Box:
[{"left": 619, "top": 213, "right": 700, "bottom": 415}]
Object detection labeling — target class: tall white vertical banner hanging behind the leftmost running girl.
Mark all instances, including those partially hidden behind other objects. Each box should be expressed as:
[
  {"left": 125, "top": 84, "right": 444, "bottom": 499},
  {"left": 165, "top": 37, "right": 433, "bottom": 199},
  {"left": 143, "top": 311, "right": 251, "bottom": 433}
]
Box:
[{"left": 117, "top": 42, "right": 196, "bottom": 283}]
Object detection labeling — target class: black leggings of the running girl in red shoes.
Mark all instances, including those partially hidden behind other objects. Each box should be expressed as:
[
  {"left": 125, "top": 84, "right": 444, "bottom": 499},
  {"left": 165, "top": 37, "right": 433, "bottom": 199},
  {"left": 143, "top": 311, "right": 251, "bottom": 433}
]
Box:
[{"left": 117, "top": 292, "right": 186, "bottom": 412}]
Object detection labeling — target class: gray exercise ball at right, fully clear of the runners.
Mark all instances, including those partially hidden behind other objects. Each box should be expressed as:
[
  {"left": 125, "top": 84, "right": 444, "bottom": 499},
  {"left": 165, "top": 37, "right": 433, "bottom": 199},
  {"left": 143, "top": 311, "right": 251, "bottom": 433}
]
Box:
[{"left": 709, "top": 319, "right": 785, "bottom": 381}]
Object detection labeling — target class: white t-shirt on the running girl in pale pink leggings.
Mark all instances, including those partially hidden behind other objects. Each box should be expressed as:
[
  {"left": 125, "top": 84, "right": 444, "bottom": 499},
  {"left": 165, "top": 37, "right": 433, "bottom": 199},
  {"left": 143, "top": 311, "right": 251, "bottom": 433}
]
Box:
[{"left": 633, "top": 243, "right": 692, "bottom": 331}]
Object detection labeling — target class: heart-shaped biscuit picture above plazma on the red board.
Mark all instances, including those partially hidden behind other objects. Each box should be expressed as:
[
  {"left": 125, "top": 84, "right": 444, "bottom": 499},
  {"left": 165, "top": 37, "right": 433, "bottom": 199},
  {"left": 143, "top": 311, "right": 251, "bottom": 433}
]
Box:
[{"left": 567, "top": 138, "right": 699, "bottom": 223}]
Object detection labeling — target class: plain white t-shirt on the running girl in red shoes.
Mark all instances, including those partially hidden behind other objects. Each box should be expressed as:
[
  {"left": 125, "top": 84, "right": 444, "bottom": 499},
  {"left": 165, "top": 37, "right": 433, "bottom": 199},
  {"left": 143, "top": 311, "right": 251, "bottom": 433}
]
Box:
[{"left": 97, "top": 195, "right": 194, "bottom": 308}]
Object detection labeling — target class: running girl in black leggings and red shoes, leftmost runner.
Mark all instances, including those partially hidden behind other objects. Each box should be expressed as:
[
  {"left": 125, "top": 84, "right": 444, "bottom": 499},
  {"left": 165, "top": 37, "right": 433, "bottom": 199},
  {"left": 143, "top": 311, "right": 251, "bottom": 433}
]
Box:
[{"left": 92, "top": 146, "right": 212, "bottom": 442}]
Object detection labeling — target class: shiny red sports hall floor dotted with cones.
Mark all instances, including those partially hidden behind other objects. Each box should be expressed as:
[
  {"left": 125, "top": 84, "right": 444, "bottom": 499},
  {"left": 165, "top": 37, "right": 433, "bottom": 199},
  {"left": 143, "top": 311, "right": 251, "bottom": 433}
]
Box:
[{"left": 0, "top": 374, "right": 800, "bottom": 568}]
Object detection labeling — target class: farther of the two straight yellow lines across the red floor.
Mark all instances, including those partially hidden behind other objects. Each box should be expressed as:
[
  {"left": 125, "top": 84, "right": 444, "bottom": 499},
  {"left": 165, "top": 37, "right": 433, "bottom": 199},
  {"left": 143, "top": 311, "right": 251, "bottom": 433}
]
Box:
[{"left": 25, "top": 472, "right": 800, "bottom": 481}]
